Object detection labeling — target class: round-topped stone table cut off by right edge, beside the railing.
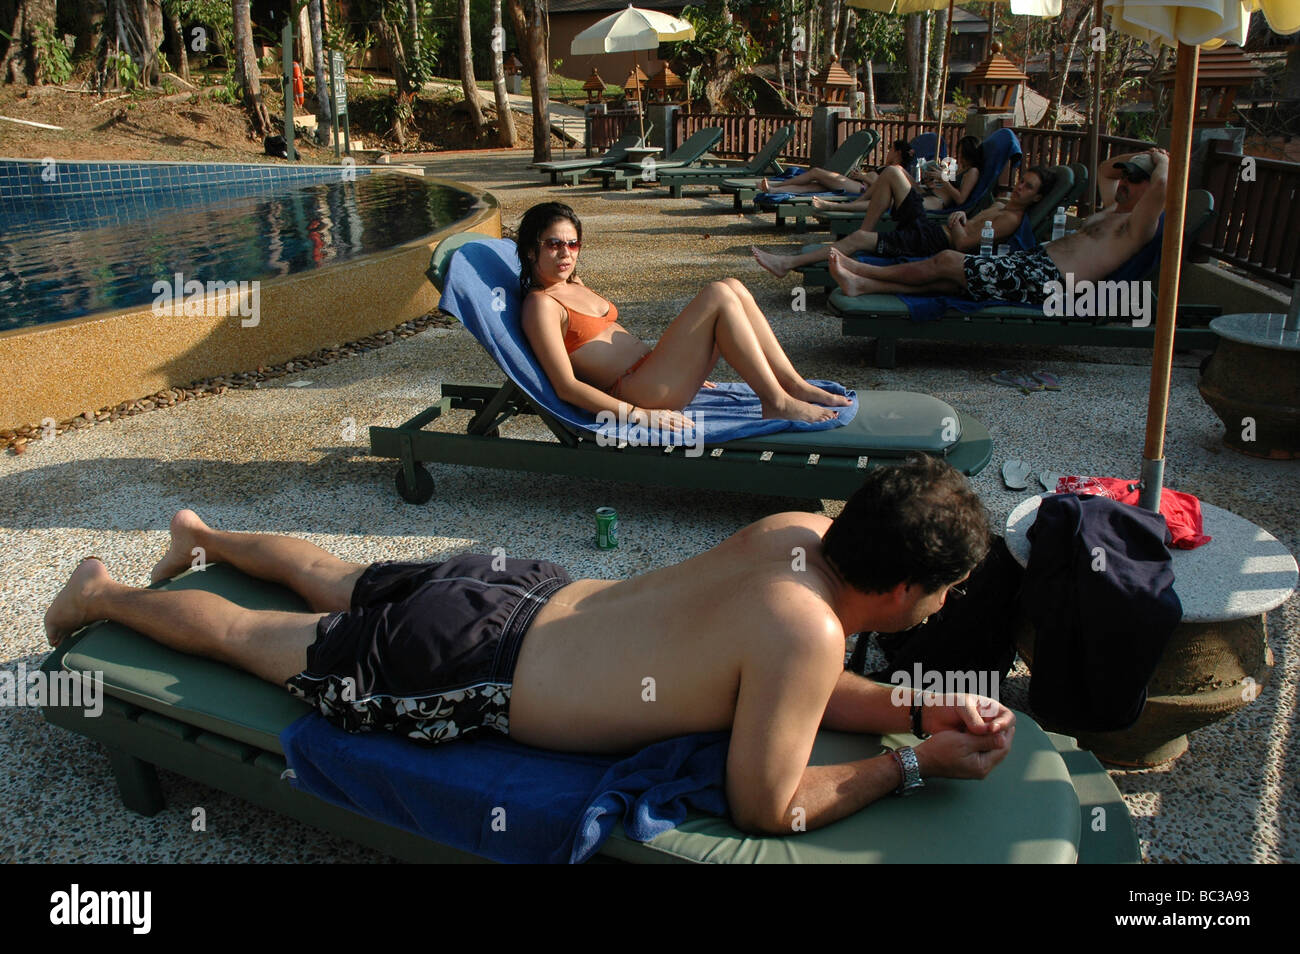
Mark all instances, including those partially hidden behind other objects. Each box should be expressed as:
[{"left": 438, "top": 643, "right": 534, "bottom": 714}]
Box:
[{"left": 1197, "top": 313, "right": 1300, "bottom": 460}]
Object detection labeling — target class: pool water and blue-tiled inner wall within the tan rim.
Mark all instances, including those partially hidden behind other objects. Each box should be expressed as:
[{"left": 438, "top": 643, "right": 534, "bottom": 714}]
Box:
[{"left": 0, "top": 161, "right": 476, "bottom": 331}]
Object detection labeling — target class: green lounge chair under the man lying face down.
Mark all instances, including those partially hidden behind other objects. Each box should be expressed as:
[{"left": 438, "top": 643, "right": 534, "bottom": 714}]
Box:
[{"left": 42, "top": 564, "right": 1139, "bottom": 863}]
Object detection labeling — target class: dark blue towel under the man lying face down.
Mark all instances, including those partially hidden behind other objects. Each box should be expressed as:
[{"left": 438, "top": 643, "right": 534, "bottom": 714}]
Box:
[{"left": 280, "top": 712, "right": 731, "bottom": 864}]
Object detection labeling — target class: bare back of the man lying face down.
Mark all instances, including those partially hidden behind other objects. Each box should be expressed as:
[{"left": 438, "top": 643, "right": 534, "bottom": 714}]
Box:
[{"left": 510, "top": 513, "right": 846, "bottom": 751}]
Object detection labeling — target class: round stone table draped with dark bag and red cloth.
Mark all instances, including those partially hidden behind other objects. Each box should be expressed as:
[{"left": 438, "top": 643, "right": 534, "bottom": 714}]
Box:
[{"left": 1006, "top": 494, "right": 1296, "bottom": 766}]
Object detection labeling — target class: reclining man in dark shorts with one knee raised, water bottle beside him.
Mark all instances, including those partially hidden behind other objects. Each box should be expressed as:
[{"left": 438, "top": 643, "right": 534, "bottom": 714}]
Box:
[{"left": 750, "top": 165, "right": 1056, "bottom": 278}]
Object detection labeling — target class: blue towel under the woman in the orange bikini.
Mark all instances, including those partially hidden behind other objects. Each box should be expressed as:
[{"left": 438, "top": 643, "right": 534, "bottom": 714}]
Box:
[{"left": 439, "top": 239, "right": 858, "bottom": 446}]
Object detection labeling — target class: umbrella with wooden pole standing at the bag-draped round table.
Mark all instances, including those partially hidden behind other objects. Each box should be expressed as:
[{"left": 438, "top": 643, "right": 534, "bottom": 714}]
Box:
[{"left": 1102, "top": 0, "right": 1300, "bottom": 512}]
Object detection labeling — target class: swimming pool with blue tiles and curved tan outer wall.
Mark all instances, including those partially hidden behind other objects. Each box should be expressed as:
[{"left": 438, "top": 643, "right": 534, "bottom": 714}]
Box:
[{"left": 0, "top": 159, "right": 501, "bottom": 429}]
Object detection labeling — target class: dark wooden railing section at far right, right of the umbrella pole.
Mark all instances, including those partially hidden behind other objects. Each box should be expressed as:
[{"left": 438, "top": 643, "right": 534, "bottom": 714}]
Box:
[{"left": 1196, "top": 140, "right": 1300, "bottom": 287}]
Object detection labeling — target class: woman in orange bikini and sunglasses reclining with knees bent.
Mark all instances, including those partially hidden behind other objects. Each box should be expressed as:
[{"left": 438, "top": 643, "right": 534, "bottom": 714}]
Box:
[{"left": 516, "top": 203, "right": 849, "bottom": 429}]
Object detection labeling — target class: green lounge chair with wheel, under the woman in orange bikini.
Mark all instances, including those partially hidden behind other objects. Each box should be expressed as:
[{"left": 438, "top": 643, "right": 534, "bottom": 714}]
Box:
[{"left": 371, "top": 233, "right": 993, "bottom": 503}]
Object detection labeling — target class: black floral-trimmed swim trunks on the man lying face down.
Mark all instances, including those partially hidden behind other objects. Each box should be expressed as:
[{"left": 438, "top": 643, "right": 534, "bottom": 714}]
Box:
[{"left": 286, "top": 554, "right": 569, "bottom": 742}]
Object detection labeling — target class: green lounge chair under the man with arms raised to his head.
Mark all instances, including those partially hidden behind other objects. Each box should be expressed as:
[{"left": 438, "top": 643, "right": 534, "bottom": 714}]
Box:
[{"left": 829, "top": 188, "right": 1221, "bottom": 368}]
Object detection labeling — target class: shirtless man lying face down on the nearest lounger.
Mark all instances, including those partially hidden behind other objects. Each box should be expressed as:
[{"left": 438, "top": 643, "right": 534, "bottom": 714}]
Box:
[{"left": 46, "top": 458, "right": 1015, "bottom": 833}]
